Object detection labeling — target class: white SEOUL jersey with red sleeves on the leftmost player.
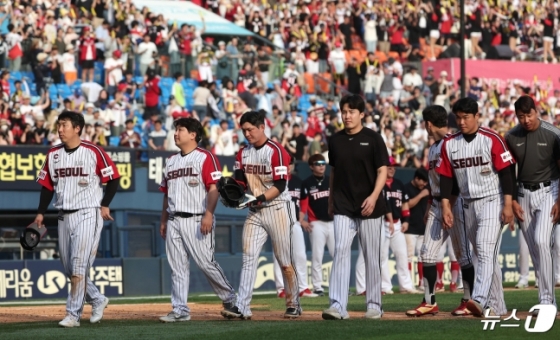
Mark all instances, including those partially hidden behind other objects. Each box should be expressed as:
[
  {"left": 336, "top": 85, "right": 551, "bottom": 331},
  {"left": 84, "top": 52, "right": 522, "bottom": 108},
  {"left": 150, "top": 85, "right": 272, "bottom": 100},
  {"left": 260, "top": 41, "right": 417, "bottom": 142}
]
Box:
[{"left": 37, "top": 141, "right": 120, "bottom": 210}]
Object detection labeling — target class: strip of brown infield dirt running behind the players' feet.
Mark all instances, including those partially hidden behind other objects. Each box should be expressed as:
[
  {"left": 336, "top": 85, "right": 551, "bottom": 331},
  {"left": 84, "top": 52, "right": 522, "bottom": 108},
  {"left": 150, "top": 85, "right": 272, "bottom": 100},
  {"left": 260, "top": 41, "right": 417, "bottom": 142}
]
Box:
[{"left": 0, "top": 303, "right": 548, "bottom": 324}]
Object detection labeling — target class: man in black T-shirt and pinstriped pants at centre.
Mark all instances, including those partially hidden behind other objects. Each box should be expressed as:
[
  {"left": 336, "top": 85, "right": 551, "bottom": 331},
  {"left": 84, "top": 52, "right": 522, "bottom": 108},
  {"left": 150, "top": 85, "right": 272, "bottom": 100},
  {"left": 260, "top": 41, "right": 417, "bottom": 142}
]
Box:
[{"left": 322, "top": 95, "right": 389, "bottom": 320}]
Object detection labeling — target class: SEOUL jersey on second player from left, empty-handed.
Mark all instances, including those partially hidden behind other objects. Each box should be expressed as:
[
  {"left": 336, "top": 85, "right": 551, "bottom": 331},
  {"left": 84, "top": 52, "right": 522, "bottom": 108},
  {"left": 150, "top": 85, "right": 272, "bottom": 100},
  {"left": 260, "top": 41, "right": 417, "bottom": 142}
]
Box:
[{"left": 160, "top": 148, "right": 222, "bottom": 215}]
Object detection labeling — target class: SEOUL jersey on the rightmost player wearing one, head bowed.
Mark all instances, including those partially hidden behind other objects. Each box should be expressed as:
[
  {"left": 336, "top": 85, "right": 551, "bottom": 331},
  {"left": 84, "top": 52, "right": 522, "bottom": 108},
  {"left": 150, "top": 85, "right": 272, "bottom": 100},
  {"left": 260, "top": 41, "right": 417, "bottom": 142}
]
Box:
[{"left": 436, "top": 127, "right": 515, "bottom": 199}]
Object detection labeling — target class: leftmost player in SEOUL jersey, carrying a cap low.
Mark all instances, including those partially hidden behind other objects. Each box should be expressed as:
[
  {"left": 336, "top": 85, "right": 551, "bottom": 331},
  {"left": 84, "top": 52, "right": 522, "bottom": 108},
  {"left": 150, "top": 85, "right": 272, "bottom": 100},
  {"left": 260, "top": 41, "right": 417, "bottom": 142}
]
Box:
[{"left": 35, "top": 111, "right": 120, "bottom": 328}]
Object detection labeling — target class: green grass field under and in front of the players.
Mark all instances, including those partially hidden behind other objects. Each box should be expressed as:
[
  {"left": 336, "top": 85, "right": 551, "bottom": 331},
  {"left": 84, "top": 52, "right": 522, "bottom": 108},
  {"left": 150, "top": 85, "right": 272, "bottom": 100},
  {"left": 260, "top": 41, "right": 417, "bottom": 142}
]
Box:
[{"left": 0, "top": 289, "right": 560, "bottom": 340}]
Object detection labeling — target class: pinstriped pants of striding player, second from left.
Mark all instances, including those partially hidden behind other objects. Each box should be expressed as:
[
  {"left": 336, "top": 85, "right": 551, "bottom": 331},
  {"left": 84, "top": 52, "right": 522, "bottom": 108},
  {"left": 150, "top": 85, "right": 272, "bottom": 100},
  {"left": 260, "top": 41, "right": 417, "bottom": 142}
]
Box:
[{"left": 165, "top": 216, "right": 235, "bottom": 315}]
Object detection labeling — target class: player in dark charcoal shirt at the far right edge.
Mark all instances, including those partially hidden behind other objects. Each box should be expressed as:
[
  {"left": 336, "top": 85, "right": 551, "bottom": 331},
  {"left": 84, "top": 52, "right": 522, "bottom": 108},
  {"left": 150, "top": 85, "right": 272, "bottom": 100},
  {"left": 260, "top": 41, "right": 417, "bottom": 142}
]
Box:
[{"left": 506, "top": 96, "right": 560, "bottom": 305}]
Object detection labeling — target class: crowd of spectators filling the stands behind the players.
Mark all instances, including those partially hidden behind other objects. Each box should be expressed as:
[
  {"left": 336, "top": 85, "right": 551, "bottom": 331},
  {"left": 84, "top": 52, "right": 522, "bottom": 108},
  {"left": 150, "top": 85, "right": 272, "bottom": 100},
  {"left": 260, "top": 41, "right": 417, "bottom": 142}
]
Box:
[{"left": 0, "top": 0, "right": 560, "bottom": 167}]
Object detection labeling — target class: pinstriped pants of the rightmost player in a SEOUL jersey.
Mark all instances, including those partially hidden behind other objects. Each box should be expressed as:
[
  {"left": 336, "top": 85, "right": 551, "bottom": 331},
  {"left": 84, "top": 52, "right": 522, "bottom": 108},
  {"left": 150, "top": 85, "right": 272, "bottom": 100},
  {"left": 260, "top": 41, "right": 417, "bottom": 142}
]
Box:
[{"left": 463, "top": 195, "right": 507, "bottom": 315}]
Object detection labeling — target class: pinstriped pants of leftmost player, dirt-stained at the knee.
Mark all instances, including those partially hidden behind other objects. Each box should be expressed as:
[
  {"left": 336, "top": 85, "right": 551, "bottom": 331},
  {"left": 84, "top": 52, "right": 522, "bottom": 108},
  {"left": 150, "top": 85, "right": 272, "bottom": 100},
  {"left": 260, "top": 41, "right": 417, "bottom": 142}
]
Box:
[{"left": 58, "top": 208, "right": 104, "bottom": 320}]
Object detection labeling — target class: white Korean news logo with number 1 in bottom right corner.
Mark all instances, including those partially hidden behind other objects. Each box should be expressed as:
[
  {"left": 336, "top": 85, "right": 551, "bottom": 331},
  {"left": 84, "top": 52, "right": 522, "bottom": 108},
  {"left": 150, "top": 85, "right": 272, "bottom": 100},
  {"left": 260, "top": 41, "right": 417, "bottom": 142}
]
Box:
[{"left": 480, "top": 305, "right": 558, "bottom": 333}]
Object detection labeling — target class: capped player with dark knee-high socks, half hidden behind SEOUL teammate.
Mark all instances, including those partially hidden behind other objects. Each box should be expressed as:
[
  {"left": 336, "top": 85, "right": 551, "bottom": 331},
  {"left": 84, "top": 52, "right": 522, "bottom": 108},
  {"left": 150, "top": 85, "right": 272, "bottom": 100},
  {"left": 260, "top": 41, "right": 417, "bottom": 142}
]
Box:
[{"left": 406, "top": 105, "right": 474, "bottom": 316}]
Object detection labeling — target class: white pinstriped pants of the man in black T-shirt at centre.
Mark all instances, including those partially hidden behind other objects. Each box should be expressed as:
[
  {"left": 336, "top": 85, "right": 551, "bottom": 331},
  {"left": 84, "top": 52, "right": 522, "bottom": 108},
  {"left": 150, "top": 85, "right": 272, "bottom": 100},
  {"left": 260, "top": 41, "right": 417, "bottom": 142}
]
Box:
[{"left": 329, "top": 215, "right": 384, "bottom": 317}]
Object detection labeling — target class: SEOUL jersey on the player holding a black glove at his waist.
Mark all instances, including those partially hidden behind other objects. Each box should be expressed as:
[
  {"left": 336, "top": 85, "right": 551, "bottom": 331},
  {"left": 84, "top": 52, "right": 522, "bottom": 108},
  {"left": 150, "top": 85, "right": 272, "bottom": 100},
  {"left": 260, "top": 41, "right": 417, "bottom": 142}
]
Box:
[{"left": 234, "top": 140, "right": 292, "bottom": 206}]
